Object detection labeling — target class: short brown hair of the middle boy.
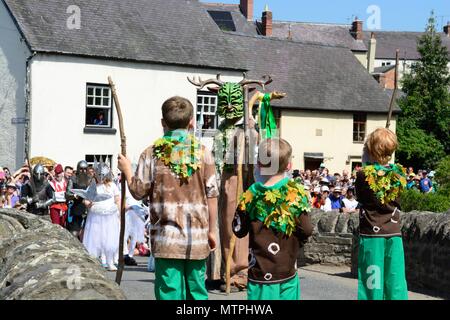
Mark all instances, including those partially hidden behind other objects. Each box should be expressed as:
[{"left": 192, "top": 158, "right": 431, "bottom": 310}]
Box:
[{"left": 258, "top": 138, "right": 292, "bottom": 174}]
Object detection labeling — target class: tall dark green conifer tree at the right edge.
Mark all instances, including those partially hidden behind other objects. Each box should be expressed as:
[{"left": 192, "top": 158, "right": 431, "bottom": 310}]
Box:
[{"left": 397, "top": 13, "right": 450, "bottom": 168}]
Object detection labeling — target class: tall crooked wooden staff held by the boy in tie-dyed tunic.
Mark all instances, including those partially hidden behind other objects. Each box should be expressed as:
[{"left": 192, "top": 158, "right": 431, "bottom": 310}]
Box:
[{"left": 108, "top": 77, "right": 127, "bottom": 286}]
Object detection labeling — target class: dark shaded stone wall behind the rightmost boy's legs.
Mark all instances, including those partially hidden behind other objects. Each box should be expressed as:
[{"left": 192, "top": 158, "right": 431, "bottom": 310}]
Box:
[{"left": 351, "top": 210, "right": 450, "bottom": 298}]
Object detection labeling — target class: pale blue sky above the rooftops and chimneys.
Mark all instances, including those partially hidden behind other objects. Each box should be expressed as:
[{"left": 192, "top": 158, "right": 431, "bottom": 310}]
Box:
[{"left": 201, "top": 0, "right": 450, "bottom": 31}]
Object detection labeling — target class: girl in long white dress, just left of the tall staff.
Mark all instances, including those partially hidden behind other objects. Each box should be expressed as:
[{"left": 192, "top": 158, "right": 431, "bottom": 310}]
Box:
[{"left": 83, "top": 164, "right": 120, "bottom": 271}]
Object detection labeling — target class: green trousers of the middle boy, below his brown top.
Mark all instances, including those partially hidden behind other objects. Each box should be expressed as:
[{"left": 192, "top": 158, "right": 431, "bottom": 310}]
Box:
[{"left": 247, "top": 274, "right": 300, "bottom": 300}]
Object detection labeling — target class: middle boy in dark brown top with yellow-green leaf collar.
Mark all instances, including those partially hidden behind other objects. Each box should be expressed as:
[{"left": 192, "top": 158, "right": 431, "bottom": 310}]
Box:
[{"left": 232, "top": 139, "right": 312, "bottom": 300}]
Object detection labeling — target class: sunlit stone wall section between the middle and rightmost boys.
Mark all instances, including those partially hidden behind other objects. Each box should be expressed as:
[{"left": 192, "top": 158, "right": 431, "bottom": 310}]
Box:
[{"left": 299, "top": 210, "right": 358, "bottom": 266}]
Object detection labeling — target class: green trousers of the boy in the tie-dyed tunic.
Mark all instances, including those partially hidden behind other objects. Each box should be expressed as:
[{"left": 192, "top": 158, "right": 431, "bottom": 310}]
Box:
[{"left": 155, "top": 258, "right": 208, "bottom": 300}]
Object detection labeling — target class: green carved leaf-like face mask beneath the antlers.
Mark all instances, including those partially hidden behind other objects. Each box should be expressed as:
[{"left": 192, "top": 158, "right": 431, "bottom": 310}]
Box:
[{"left": 217, "top": 82, "right": 244, "bottom": 119}]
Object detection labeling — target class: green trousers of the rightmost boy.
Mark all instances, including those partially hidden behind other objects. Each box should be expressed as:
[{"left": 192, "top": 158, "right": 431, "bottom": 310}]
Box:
[{"left": 358, "top": 236, "right": 408, "bottom": 300}]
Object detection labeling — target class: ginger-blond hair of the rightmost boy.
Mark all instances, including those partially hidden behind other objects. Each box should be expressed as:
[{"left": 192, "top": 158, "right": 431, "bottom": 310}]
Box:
[{"left": 364, "top": 128, "right": 398, "bottom": 165}]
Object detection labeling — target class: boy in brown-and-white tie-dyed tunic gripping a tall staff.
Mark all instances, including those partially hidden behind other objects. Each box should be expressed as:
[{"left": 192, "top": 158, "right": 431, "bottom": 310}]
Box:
[{"left": 119, "top": 97, "right": 218, "bottom": 300}]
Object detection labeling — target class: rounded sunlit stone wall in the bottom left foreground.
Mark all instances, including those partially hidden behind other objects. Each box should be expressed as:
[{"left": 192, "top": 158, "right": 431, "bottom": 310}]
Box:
[{"left": 0, "top": 209, "right": 125, "bottom": 300}]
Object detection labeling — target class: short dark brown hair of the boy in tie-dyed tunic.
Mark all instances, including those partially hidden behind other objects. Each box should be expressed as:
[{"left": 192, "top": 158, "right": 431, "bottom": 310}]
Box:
[{"left": 161, "top": 96, "right": 194, "bottom": 130}]
